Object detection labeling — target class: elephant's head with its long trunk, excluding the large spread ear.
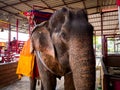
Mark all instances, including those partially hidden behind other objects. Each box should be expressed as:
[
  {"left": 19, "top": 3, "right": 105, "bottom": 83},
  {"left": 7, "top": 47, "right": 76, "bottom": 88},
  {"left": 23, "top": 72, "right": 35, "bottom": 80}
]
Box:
[{"left": 49, "top": 8, "right": 95, "bottom": 90}]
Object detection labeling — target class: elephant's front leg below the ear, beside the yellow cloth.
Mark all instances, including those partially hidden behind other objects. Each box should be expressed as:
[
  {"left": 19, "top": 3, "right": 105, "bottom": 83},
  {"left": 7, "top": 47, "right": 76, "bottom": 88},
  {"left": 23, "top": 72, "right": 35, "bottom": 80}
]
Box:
[{"left": 36, "top": 51, "right": 56, "bottom": 90}]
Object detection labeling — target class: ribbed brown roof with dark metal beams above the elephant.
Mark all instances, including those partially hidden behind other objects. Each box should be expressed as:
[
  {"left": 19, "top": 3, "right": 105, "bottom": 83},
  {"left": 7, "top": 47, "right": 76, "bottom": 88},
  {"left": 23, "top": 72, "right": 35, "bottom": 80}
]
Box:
[{"left": 0, "top": 0, "right": 119, "bottom": 35}]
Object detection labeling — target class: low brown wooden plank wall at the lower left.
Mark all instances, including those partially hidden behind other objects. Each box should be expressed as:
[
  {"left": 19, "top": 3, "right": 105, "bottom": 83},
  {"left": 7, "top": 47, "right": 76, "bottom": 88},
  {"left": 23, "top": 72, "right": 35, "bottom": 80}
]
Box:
[{"left": 0, "top": 62, "right": 18, "bottom": 88}]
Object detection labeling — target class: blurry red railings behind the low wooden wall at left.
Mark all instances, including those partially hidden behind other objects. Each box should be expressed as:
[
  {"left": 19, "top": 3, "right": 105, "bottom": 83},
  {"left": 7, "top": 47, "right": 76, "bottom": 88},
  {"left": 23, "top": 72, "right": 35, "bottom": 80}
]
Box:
[{"left": 0, "top": 41, "right": 24, "bottom": 63}]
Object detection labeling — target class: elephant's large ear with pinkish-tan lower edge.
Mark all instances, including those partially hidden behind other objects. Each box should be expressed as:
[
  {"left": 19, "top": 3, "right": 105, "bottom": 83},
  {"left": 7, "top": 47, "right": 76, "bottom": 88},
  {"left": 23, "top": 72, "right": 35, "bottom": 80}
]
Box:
[{"left": 31, "top": 22, "right": 55, "bottom": 57}]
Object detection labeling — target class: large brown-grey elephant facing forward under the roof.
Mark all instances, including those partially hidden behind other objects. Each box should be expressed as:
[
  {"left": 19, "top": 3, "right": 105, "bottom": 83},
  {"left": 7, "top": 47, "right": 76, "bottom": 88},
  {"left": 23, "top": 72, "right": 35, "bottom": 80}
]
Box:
[{"left": 31, "top": 7, "right": 95, "bottom": 90}]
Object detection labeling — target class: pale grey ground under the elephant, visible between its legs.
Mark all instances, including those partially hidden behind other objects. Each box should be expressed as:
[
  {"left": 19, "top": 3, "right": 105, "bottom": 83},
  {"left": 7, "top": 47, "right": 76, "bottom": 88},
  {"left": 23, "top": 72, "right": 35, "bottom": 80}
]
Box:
[{"left": 0, "top": 77, "right": 64, "bottom": 90}]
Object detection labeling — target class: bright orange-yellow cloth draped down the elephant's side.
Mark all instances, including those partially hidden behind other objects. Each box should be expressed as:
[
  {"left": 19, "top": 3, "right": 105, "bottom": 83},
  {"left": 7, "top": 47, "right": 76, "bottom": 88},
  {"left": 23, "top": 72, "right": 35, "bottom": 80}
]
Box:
[{"left": 16, "top": 39, "right": 35, "bottom": 79}]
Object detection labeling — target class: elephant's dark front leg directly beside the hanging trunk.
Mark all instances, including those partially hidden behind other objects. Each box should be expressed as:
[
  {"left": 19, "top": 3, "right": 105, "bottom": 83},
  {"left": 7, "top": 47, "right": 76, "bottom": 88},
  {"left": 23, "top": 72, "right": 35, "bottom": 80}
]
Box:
[{"left": 64, "top": 73, "right": 75, "bottom": 90}]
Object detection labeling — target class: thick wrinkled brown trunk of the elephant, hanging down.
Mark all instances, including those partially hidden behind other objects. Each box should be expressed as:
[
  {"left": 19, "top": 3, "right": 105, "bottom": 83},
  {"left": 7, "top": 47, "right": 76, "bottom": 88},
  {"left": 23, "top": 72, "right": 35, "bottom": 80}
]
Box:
[{"left": 69, "top": 34, "right": 95, "bottom": 90}]
